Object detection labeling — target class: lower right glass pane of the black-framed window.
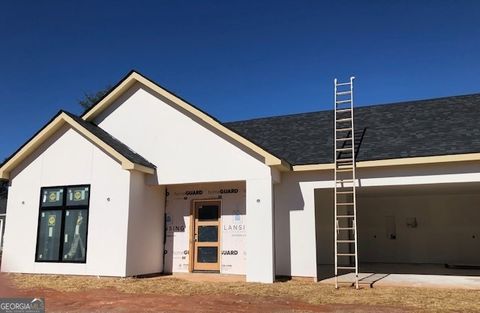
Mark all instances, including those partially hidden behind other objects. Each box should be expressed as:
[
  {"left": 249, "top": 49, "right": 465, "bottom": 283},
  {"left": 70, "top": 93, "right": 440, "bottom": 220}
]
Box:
[{"left": 63, "top": 210, "right": 88, "bottom": 262}]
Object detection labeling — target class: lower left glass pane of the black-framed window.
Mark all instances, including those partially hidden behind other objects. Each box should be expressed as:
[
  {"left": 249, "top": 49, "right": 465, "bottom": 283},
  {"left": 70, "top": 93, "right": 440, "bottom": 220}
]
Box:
[{"left": 37, "top": 210, "right": 62, "bottom": 261}]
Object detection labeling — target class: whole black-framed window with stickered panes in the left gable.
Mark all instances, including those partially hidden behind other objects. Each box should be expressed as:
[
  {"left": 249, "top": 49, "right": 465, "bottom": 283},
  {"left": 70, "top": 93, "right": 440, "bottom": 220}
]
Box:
[{"left": 35, "top": 185, "right": 90, "bottom": 263}]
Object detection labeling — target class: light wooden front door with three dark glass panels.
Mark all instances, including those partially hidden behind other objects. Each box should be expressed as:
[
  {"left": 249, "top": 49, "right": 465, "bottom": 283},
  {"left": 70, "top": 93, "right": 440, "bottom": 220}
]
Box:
[{"left": 192, "top": 200, "right": 221, "bottom": 271}]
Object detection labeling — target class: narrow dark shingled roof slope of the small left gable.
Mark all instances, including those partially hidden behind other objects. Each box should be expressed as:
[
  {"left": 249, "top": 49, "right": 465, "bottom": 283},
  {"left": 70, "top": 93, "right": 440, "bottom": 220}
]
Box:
[{"left": 62, "top": 111, "right": 156, "bottom": 169}]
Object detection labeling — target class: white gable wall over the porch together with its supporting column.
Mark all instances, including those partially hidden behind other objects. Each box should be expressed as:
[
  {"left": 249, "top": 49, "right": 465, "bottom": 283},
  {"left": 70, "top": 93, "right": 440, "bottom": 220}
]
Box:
[{"left": 90, "top": 84, "right": 274, "bottom": 282}]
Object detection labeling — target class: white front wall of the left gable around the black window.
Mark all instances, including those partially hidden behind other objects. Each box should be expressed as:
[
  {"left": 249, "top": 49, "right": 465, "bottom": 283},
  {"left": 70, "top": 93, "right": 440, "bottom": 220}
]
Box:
[{"left": 2, "top": 126, "right": 130, "bottom": 276}]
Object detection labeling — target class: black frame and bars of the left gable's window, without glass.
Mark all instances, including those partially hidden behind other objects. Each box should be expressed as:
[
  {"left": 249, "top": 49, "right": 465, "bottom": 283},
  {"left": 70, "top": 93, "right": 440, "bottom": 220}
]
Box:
[{"left": 35, "top": 184, "right": 92, "bottom": 264}]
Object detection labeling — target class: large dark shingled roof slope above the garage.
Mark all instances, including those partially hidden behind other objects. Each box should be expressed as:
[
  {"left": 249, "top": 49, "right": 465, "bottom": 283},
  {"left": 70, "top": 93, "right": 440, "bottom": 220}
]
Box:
[{"left": 224, "top": 94, "right": 480, "bottom": 165}]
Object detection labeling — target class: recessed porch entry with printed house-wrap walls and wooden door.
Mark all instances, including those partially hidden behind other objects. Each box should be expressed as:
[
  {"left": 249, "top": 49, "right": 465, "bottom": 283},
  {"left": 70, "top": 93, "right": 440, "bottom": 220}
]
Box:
[{"left": 164, "top": 181, "right": 247, "bottom": 275}]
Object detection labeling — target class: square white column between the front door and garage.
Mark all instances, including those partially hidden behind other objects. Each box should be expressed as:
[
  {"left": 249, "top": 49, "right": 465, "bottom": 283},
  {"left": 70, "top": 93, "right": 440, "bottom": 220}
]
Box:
[{"left": 246, "top": 177, "right": 275, "bottom": 283}]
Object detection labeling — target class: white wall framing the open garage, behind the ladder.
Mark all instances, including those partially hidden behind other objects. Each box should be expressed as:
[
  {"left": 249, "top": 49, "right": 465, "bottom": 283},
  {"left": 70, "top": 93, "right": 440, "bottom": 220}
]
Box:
[{"left": 275, "top": 162, "right": 480, "bottom": 277}]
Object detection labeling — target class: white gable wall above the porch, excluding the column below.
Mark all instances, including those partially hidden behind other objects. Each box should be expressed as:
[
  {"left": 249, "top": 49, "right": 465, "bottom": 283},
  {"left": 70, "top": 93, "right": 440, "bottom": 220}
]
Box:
[{"left": 94, "top": 84, "right": 270, "bottom": 185}]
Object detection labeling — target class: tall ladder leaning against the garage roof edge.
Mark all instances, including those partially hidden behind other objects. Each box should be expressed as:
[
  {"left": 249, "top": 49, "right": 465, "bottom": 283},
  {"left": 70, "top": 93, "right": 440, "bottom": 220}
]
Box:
[{"left": 334, "top": 76, "right": 358, "bottom": 289}]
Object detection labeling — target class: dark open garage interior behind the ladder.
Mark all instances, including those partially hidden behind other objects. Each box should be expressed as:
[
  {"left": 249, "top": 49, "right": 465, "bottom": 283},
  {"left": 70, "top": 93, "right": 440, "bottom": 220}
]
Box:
[{"left": 315, "top": 183, "right": 480, "bottom": 284}]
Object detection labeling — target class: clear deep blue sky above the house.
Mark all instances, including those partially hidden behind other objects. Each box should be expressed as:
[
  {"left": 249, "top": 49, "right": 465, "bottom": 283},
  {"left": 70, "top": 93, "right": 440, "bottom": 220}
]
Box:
[{"left": 0, "top": 0, "right": 480, "bottom": 162}]
